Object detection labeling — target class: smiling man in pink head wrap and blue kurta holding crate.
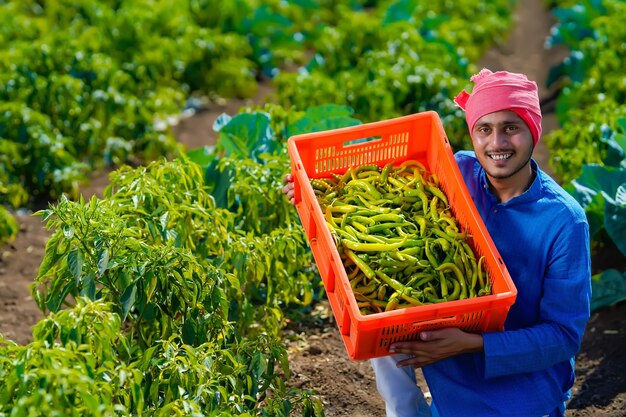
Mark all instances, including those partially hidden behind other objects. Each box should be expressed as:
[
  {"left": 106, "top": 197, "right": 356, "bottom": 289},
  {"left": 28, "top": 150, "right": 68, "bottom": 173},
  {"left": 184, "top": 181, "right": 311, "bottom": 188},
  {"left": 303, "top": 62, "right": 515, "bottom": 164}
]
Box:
[{"left": 285, "top": 69, "right": 591, "bottom": 417}]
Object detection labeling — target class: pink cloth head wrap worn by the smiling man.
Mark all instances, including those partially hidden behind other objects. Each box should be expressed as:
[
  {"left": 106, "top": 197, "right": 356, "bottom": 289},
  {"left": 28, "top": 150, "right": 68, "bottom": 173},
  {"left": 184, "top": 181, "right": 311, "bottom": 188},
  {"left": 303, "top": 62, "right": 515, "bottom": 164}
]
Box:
[{"left": 454, "top": 68, "right": 541, "bottom": 145}]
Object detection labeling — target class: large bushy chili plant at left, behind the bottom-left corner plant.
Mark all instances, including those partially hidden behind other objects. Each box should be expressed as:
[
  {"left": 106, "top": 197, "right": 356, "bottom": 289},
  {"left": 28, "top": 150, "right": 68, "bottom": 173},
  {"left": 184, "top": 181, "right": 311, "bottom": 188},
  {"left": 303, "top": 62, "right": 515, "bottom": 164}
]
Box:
[{"left": 33, "top": 156, "right": 234, "bottom": 346}]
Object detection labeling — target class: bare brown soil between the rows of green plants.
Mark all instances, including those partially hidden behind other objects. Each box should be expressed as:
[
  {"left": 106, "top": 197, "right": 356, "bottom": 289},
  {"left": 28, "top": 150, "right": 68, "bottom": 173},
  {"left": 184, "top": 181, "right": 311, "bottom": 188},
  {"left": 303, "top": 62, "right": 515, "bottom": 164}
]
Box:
[{"left": 0, "top": 0, "right": 626, "bottom": 417}]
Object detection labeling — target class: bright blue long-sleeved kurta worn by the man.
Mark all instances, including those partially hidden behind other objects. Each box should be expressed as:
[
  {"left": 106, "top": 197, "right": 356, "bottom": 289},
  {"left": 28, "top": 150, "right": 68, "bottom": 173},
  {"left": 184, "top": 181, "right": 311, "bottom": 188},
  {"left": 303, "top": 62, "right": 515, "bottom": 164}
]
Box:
[{"left": 423, "top": 151, "right": 591, "bottom": 417}]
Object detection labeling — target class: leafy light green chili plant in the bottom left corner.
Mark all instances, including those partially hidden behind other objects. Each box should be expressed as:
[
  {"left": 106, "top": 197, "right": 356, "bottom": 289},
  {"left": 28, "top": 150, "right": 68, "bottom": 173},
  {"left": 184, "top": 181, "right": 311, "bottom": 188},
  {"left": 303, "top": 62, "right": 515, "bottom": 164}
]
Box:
[{"left": 0, "top": 298, "right": 143, "bottom": 417}]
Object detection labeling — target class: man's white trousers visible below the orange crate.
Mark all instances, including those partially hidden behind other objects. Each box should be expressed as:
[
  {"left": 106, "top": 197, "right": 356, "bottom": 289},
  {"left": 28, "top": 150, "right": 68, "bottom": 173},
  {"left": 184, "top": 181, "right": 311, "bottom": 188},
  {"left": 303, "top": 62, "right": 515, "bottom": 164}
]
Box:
[{"left": 370, "top": 354, "right": 431, "bottom": 417}]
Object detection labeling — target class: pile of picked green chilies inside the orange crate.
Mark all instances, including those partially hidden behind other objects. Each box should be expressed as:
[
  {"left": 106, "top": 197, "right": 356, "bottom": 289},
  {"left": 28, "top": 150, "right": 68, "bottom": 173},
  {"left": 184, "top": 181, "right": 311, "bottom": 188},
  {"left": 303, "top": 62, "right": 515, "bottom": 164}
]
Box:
[{"left": 311, "top": 160, "right": 491, "bottom": 315}]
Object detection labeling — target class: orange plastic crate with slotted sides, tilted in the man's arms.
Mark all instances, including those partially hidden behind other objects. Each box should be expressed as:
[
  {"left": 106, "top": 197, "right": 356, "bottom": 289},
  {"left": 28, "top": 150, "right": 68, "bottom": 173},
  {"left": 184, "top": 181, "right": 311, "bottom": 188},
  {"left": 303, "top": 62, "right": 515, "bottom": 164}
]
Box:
[{"left": 289, "top": 111, "right": 517, "bottom": 360}]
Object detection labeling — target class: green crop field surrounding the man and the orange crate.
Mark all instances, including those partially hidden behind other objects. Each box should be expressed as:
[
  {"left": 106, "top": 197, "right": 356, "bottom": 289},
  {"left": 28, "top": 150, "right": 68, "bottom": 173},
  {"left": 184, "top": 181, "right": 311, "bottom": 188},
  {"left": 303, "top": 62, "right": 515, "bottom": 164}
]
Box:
[{"left": 0, "top": 0, "right": 626, "bottom": 417}]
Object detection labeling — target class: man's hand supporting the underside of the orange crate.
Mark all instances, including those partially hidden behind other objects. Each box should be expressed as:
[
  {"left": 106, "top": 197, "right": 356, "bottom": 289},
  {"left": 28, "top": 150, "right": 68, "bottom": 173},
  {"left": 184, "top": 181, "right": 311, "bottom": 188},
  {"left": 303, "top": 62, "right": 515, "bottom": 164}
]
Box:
[{"left": 389, "top": 327, "right": 483, "bottom": 368}]
